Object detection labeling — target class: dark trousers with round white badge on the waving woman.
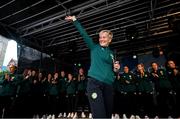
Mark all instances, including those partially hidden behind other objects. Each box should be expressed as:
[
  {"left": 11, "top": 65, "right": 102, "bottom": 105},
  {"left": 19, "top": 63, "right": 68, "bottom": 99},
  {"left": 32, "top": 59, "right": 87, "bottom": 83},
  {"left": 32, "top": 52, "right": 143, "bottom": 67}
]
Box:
[{"left": 87, "top": 78, "right": 113, "bottom": 118}]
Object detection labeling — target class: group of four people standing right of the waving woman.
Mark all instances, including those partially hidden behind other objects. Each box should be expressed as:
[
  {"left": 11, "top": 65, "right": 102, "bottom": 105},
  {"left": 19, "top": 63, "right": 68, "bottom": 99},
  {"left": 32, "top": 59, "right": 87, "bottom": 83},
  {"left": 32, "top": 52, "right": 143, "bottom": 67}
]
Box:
[{"left": 114, "top": 60, "right": 180, "bottom": 118}]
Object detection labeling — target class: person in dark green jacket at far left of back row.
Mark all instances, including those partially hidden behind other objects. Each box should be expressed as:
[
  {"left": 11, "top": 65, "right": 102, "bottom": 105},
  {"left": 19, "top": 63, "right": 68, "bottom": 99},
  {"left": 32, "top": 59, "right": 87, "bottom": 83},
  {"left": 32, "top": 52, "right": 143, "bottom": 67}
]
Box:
[{"left": 0, "top": 65, "right": 19, "bottom": 118}]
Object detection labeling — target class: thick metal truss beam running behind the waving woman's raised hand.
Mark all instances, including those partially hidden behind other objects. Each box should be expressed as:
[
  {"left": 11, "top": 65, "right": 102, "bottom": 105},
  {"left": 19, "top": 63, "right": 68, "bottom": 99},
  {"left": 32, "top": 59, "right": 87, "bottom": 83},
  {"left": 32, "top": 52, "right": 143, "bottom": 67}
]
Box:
[{"left": 18, "top": 0, "right": 131, "bottom": 37}]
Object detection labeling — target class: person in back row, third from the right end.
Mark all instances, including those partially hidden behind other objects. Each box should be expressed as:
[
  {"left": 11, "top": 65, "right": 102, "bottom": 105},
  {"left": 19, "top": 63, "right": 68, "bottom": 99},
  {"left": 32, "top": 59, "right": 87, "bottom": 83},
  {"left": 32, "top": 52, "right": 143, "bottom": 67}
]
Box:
[{"left": 135, "top": 63, "right": 153, "bottom": 116}]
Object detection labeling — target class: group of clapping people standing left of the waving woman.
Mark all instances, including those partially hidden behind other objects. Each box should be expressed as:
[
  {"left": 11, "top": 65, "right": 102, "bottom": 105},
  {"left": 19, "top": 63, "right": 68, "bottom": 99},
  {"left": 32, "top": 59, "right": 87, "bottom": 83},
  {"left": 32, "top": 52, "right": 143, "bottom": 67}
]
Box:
[{"left": 0, "top": 66, "right": 89, "bottom": 118}]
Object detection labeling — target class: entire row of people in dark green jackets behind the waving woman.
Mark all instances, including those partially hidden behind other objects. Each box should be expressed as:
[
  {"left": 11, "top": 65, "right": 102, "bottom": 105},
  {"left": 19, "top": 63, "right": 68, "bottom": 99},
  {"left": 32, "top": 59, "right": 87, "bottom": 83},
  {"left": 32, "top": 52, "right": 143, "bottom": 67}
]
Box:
[{"left": 0, "top": 60, "right": 180, "bottom": 118}]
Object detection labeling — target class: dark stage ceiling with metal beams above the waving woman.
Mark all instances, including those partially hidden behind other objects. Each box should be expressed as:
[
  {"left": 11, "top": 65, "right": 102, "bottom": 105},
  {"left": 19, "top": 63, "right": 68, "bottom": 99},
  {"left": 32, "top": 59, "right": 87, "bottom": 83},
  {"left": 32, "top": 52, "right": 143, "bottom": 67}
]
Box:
[{"left": 0, "top": 0, "right": 180, "bottom": 61}]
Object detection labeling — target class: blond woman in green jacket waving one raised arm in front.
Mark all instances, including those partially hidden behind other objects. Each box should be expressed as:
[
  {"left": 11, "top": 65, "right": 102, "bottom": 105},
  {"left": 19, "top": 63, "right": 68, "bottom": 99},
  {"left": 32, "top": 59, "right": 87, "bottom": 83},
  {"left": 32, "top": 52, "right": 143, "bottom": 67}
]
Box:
[{"left": 65, "top": 16, "right": 120, "bottom": 118}]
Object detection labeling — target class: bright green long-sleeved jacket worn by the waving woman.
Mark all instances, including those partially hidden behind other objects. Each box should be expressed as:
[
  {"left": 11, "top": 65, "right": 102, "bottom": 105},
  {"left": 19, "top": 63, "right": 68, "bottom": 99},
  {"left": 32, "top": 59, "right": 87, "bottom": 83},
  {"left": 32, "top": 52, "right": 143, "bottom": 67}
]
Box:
[{"left": 73, "top": 20, "right": 114, "bottom": 85}]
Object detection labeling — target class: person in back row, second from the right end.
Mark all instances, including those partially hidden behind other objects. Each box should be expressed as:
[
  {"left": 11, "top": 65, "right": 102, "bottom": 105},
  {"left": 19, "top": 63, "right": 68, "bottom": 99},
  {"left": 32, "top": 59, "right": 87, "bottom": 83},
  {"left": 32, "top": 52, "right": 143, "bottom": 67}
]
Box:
[{"left": 150, "top": 62, "right": 172, "bottom": 118}]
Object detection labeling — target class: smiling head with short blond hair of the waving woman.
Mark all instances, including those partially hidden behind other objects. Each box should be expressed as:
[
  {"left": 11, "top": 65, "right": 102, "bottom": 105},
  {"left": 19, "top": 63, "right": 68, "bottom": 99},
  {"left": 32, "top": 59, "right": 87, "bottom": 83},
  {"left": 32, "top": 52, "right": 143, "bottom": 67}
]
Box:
[{"left": 99, "top": 30, "right": 113, "bottom": 47}]
